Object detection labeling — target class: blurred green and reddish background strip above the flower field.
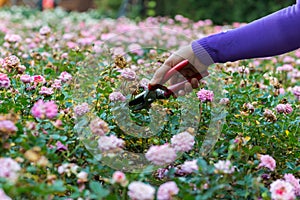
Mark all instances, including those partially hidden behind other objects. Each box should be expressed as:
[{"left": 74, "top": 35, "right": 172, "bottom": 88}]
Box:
[{"left": 0, "top": 0, "right": 295, "bottom": 24}]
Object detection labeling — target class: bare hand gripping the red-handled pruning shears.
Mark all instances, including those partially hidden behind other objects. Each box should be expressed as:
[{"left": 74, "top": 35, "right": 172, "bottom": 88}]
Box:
[{"left": 150, "top": 45, "right": 208, "bottom": 96}]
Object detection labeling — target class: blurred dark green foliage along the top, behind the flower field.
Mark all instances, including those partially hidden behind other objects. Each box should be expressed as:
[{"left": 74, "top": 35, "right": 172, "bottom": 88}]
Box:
[{"left": 97, "top": 0, "right": 295, "bottom": 25}]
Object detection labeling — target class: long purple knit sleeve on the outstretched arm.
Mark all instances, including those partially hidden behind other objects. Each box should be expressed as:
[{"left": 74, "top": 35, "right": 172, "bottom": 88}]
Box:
[{"left": 192, "top": 0, "right": 300, "bottom": 65}]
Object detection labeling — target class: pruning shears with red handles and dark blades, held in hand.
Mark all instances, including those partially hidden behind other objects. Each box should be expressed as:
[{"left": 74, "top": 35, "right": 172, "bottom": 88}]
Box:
[{"left": 129, "top": 60, "right": 209, "bottom": 111}]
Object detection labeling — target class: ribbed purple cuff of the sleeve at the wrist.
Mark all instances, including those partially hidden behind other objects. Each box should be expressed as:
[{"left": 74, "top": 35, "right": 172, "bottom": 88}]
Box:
[{"left": 192, "top": 39, "right": 216, "bottom": 66}]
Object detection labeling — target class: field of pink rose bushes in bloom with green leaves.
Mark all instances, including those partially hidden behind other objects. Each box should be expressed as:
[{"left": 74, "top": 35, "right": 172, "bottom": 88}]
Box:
[{"left": 0, "top": 7, "right": 300, "bottom": 199}]
